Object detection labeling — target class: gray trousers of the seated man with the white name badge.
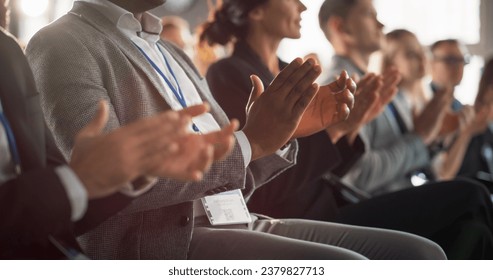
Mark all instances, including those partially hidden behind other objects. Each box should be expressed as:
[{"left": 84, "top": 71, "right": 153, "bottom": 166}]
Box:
[{"left": 188, "top": 219, "right": 446, "bottom": 260}]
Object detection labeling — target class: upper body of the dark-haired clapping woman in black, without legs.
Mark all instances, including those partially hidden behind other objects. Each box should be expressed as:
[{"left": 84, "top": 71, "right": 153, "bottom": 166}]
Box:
[{"left": 200, "top": 0, "right": 382, "bottom": 221}]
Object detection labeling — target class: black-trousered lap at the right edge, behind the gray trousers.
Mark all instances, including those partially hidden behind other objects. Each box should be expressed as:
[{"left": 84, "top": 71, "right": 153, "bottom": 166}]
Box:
[{"left": 336, "top": 179, "right": 492, "bottom": 238}]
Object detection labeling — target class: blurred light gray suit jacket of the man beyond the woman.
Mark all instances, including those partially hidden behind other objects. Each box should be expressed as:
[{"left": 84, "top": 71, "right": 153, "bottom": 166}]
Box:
[{"left": 329, "top": 56, "right": 430, "bottom": 195}]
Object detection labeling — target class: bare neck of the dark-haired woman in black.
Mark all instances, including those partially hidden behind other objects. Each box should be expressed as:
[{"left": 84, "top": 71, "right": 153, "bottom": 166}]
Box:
[{"left": 246, "top": 32, "right": 281, "bottom": 75}]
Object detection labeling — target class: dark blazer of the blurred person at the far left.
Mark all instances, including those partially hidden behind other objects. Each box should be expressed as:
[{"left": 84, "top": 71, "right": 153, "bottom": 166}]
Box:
[{"left": 0, "top": 27, "right": 75, "bottom": 259}]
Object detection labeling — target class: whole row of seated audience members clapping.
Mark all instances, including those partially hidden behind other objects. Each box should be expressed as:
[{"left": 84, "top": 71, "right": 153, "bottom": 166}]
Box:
[{"left": 0, "top": 0, "right": 493, "bottom": 259}]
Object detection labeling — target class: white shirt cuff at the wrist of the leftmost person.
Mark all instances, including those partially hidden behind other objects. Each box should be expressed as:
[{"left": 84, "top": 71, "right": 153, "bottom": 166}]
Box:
[{"left": 55, "top": 165, "right": 87, "bottom": 222}]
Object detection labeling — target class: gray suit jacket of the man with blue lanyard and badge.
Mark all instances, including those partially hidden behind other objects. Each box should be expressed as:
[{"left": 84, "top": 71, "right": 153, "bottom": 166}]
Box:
[{"left": 26, "top": 2, "right": 297, "bottom": 259}]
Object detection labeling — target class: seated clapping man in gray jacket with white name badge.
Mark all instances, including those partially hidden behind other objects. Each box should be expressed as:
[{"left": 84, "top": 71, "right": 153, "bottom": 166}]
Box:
[{"left": 27, "top": 0, "right": 444, "bottom": 259}]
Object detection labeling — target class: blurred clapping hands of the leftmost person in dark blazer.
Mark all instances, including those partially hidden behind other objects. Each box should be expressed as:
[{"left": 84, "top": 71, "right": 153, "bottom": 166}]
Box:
[{"left": 69, "top": 102, "right": 235, "bottom": 198}]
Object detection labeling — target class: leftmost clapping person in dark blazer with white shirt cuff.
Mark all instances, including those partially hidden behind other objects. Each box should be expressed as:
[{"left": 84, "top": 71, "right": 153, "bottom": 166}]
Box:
[{"left": 0, "top": 28, "right": 232, "bottom": 259}]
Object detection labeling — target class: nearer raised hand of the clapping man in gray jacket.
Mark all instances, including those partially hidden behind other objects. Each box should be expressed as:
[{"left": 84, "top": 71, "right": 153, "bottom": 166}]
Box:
[{"left": 243, "top": 58, "right": 321, "bottom": 160}]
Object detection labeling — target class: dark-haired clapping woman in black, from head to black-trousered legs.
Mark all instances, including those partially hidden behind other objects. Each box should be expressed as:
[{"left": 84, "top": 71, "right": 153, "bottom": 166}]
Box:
[{"left": 200, "top": 0, "right": 491, "bottom": 259}]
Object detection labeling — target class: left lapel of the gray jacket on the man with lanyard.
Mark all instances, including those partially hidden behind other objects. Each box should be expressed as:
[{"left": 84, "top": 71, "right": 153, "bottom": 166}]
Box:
[{"left": 69, "top": 2, "right": 175, "bottom": 104}]
